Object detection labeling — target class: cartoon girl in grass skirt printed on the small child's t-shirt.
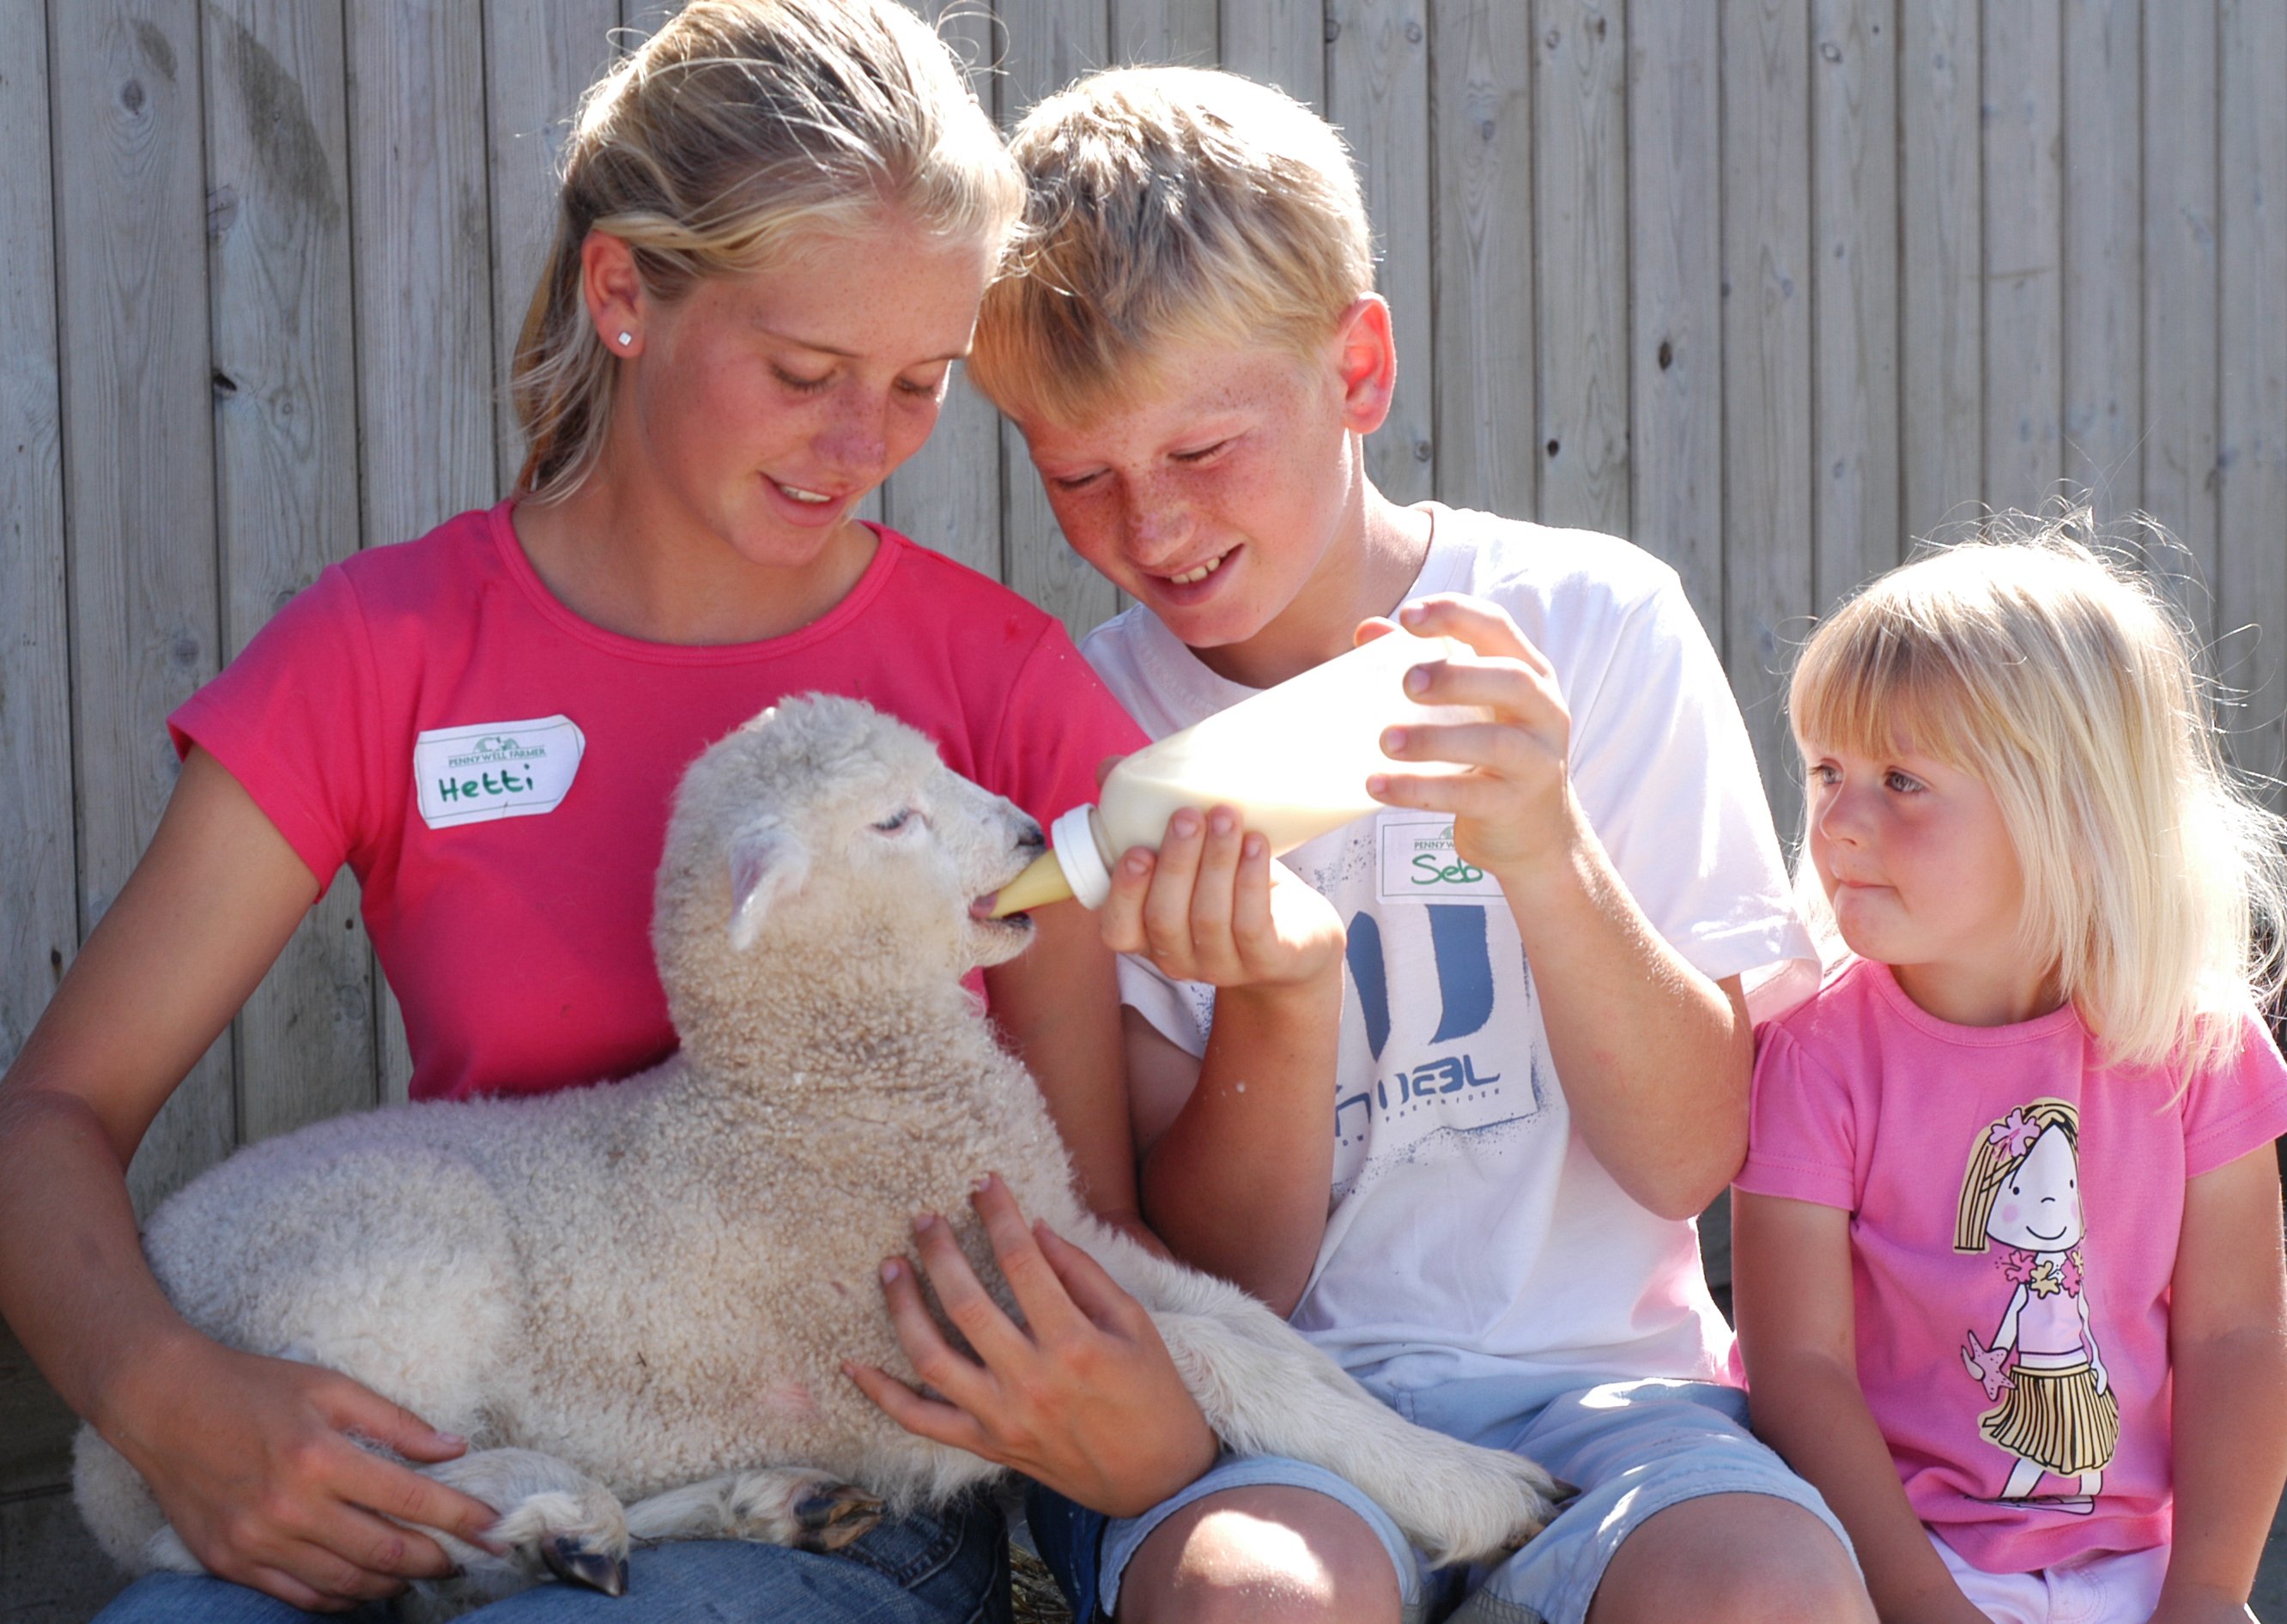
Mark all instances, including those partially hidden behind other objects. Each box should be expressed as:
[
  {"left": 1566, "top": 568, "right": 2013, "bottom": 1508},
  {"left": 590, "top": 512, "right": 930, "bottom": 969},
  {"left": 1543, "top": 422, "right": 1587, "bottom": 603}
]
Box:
[{"left": 1953, "top": 1100, "right": 2120, "bottom": 1514}]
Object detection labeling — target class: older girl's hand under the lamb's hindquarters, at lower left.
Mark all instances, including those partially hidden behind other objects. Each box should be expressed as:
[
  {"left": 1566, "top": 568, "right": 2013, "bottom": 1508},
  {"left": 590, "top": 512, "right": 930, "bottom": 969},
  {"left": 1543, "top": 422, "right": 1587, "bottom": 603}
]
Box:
[{"left": 106, "top": 1338, "right": 496, "bottom": 1613}]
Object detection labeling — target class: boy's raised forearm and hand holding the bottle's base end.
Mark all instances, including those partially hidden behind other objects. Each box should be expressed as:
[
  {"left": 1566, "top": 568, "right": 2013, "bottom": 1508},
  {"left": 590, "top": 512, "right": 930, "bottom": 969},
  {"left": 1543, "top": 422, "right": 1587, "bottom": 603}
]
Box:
[{"left": 1370, "top": 597, "right": 1754, "bottom": 1217}]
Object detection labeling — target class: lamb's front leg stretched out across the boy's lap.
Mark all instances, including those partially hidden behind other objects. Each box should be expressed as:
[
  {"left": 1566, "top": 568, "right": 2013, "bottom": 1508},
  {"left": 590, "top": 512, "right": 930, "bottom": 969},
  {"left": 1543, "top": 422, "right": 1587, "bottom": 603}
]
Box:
[{"left": 1079, "top": 1226, "right": 1556, "bottom": 1565}]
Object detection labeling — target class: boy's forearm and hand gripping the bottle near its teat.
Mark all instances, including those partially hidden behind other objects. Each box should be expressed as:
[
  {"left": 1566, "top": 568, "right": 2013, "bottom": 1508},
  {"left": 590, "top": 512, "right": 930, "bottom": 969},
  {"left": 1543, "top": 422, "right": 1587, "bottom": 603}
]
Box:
[{"left": 1102, "top": 808, "right": 1343, "bottom": 1313}]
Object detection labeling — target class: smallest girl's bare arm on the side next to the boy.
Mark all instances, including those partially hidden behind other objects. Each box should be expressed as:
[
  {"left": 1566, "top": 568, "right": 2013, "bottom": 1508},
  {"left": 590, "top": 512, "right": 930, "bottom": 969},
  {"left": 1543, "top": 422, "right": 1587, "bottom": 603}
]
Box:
[{"left": 1732, "top": 1190, "right": 1985, "bottom": 1624}]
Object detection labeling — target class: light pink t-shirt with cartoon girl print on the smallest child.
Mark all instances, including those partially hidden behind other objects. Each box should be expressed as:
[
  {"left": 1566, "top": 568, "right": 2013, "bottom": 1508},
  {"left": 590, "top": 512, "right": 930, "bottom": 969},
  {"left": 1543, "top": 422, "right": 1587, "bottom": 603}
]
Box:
[{"left": 1738, "top": 960, "right": 2287, "bottom": 1573}]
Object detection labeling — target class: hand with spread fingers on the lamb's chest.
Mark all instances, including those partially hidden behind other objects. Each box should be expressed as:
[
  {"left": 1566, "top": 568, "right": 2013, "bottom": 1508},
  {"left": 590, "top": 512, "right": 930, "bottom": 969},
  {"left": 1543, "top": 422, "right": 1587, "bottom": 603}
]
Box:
[{"left": 841, "top": 1178, "right": 1216, "bottom": 1517}]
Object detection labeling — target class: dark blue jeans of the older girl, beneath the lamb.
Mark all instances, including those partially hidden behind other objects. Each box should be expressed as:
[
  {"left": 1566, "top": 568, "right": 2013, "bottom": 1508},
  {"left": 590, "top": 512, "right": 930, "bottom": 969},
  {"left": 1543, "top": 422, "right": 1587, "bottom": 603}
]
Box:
[{"left": 99, "top": 1496, "right": 1009, "bottom": 1624}]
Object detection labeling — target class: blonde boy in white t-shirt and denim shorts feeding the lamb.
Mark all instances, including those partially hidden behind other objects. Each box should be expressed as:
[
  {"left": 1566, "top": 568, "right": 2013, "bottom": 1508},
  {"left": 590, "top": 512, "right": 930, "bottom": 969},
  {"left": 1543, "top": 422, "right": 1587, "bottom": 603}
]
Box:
[{"left": 946, "top": 69, "right": 1873, "bottom": 1624}]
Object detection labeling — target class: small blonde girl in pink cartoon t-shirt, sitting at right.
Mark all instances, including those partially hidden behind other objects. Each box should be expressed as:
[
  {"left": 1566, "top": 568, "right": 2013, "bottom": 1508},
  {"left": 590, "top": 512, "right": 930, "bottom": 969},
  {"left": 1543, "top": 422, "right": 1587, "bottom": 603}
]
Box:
[{"left": 1736, "top": 524, "right": 2287, "bottom": 1624}]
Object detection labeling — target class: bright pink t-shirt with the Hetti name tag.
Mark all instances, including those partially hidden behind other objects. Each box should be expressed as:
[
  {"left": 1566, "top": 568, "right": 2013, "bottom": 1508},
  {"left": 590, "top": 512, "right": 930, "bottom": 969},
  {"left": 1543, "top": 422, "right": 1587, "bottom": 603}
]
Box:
[{"left": 169, "top": 503, "right": 1144, "bottom": 1098}]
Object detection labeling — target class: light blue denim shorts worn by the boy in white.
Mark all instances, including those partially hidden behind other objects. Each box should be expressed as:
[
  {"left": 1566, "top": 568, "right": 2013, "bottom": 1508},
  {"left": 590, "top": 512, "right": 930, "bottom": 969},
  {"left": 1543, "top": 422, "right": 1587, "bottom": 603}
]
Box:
[{"left": 1024, "top": 1373, "right": 1850, "bottom": 1624}]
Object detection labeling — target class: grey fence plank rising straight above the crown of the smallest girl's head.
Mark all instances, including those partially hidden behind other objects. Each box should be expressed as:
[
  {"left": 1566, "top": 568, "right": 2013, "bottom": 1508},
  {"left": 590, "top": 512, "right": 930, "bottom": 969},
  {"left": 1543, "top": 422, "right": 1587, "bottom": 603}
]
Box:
[{"left": 1985, "top": 0, "right": 2066, "bottom": 521}]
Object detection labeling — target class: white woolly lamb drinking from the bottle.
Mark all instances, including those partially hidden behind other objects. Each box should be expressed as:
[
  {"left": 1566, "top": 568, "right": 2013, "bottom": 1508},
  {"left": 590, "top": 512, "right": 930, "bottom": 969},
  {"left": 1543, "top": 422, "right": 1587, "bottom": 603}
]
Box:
[{"left": 78, "top": 698, "right": 1550, "bottom": 1606}]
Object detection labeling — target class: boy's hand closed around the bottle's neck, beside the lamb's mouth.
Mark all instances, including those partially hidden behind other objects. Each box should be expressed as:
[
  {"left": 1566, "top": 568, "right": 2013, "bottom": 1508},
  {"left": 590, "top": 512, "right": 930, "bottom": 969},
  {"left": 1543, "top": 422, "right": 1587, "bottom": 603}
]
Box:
[{"left": 1100, "top": 808, "right": 1343, "bottom": 988}]
